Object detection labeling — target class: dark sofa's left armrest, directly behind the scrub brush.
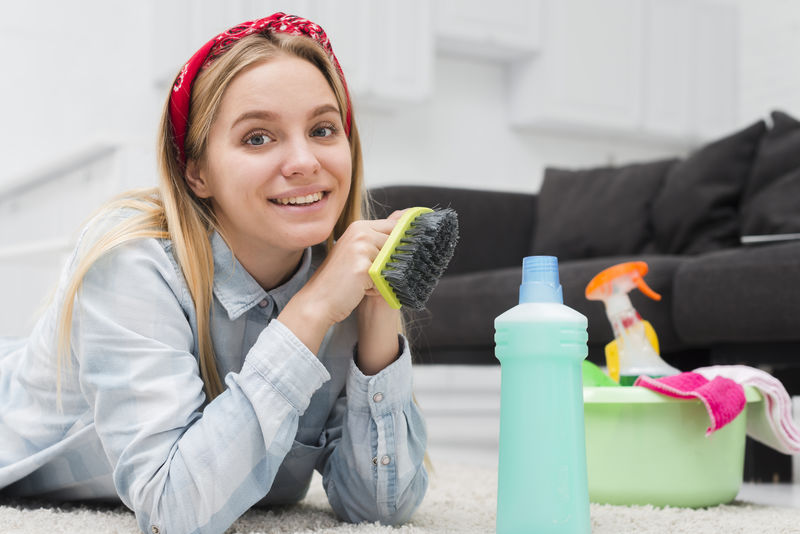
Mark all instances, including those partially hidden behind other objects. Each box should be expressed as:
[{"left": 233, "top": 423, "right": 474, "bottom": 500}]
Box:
[{"left": 369, "top": 185, "right": 537, "bottom": 274}]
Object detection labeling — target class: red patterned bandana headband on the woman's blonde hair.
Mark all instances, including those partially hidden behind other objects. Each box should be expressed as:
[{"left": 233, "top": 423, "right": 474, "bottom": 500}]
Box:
[{"left": 169, "top": 13, "right": 352, "bottom": 165}]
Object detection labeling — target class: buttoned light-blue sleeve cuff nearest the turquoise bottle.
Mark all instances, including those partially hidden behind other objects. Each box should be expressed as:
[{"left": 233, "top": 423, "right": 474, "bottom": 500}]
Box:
[{"left": 347, "top": 335, "right": 413, "bottom": 417}]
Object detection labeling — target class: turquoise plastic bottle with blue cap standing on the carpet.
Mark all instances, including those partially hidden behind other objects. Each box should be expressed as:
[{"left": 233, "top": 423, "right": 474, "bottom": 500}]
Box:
[{"left": 495, "top": 256, "right": 591, "bottom": 534}]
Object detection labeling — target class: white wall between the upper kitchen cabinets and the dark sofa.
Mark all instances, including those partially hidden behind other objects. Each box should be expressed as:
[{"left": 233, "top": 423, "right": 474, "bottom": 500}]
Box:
[{"left": 358, "top": 54, "right": 679, "bottom": 192}]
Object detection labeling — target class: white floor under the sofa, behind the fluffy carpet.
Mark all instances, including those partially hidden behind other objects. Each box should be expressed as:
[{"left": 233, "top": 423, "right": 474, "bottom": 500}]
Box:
[{"left": 414, "top": 365, "right": 800, "bottom": 508}]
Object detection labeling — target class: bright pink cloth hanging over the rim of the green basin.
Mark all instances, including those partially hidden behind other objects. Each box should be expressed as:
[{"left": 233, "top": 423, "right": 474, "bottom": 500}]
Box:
[{"left": 633, "top": 372, "right": 746, "bottom": 436}]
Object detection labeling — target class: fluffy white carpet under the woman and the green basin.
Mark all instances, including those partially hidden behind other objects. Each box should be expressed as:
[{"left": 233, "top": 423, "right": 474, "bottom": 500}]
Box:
[{"left": 0, "top": 463, "right": 800, "bottom": 534}]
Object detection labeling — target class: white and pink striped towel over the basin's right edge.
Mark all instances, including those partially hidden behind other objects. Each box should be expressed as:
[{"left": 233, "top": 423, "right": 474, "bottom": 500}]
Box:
[{"left": 694, "top": 365, "right": 800, "bottom": 454}]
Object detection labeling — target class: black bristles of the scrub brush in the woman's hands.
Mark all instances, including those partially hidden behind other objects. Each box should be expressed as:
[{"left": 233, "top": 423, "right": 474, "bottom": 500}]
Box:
[{"left": 381, "top": 208, "right": 458, "bottom": 310}]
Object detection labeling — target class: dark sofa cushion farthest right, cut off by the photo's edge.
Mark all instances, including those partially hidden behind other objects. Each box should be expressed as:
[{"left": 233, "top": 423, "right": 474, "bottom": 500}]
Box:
[{"left": 741, "top": 111, "right": 800, "bottom": 235}]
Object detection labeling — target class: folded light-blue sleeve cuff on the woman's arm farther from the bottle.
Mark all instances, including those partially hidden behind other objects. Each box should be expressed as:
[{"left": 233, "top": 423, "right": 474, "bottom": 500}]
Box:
[{"left": 244, "top": 319, "right": 331, "bottom": 414}]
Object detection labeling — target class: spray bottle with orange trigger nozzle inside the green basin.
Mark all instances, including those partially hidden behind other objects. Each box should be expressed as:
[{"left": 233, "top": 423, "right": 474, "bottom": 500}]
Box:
[{"left": 586, "top": 261, "right": 680, "bottom": 386}]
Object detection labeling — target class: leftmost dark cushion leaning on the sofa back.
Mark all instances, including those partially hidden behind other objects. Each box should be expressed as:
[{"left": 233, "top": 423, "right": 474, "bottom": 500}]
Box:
[{"left": 532, "top": 159, "right": 677, "bottom": 261}]
